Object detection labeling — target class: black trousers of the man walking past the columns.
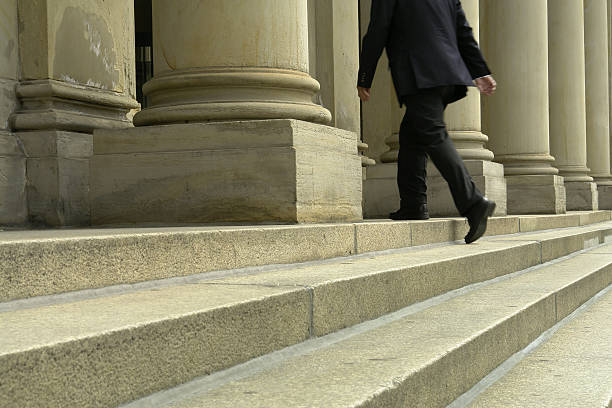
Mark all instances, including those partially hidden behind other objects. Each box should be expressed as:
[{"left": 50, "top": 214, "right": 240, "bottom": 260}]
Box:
[{"left": 397, "top": 86, "right": 482, "bottom": 216}]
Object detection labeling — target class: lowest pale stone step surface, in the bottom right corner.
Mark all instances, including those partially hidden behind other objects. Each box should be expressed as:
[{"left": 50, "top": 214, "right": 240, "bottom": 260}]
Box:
[{"left": 464, "top": 286, "right": 612, "bottom": 408}]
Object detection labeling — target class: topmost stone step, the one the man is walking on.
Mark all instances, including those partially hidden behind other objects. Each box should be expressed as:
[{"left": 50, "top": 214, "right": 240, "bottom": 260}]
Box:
[{"left": 0, "top": 211, "right": 612, "bottom": 302}]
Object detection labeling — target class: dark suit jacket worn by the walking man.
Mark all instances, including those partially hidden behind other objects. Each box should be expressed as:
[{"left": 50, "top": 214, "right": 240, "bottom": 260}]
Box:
[{"left": 357, "top": 0, "right": 490, "bottom": 103}]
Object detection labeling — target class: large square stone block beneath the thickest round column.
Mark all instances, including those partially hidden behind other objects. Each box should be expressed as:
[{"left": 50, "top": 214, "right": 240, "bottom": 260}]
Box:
[{"left": 90, "top": 119, "right": 362, "bottom": 225}]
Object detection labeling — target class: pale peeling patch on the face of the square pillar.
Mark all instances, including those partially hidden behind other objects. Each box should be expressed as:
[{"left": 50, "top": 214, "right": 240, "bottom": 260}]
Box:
[{"left": 53, "top": 7, "right": 121, "bottom": 90}]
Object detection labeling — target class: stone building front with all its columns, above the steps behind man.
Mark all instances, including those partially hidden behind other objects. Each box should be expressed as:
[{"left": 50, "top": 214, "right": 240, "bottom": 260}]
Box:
[{"left": 0, "top": 0, "right": 612, "bottom": 226}]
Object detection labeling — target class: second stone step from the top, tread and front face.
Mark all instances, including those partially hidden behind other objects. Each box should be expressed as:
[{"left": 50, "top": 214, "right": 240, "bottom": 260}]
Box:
[{"left": 0, "top": 222, "right": 612, "bottom": 407}]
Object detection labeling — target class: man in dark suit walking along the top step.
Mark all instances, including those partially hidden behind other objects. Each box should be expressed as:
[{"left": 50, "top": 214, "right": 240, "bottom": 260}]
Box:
[{"left": 357, "top": 0, "right": 496, "bottom": 244}]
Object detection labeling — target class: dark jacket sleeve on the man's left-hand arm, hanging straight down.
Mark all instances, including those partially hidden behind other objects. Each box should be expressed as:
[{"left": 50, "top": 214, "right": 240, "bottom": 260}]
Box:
[{"left": 357, "top": 0, "right": 397, "bottom": 88}]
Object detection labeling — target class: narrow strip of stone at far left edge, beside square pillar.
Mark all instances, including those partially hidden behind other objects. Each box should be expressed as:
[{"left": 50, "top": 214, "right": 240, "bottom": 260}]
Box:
[{"left": 0, "top": 0, "right": 27, "bottom": 225}]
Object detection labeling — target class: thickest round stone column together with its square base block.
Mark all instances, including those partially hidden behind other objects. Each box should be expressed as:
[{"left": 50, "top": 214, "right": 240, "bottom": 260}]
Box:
[{"left": 91, "top": 0, "right": 362, "bottom": 224}]
